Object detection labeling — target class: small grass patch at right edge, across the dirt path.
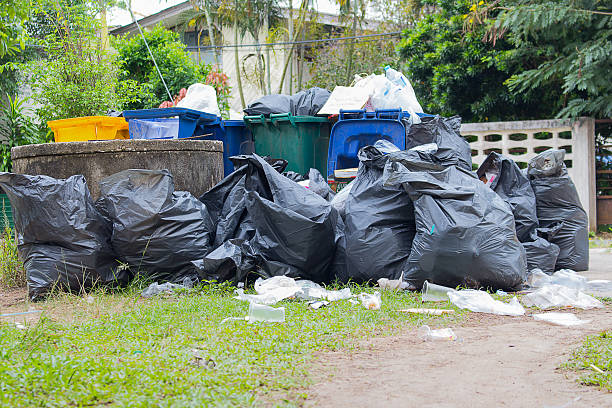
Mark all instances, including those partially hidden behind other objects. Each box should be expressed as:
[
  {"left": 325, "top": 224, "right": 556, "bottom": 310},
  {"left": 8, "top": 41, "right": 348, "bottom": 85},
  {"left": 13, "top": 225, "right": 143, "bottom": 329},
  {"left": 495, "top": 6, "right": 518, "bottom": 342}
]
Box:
[{"left": 564, "top": 331, "right": 612, "bottom": 391}]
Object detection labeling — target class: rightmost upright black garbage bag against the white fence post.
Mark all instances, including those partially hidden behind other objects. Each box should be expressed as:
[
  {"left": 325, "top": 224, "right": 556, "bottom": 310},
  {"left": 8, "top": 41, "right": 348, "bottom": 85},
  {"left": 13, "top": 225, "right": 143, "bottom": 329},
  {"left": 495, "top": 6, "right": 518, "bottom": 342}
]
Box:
[{"left": 527, "top": 149, "right": 589, "bottom": 271}]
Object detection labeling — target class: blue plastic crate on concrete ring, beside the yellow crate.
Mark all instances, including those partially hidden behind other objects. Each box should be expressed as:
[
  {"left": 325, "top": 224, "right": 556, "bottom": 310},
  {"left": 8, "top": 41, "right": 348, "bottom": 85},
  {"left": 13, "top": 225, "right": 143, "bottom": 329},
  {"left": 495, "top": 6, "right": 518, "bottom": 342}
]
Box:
[{"left": 123, "top": 108, "right": 219, "bottom": 139}]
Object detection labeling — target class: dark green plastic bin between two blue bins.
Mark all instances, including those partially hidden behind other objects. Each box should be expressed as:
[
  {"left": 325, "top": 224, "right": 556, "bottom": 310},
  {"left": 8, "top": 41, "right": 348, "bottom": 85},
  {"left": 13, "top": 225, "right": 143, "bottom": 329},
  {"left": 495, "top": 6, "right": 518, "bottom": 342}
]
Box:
[{"left": 244, "top": 113, "right": 330, "bottom": 174}]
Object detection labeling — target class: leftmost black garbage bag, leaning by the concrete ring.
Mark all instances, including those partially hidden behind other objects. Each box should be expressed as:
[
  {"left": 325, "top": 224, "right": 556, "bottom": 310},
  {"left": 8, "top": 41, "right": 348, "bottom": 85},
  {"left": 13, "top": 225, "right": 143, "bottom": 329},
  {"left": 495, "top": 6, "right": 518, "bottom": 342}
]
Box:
[{"left": 0, "top": 173, "right": 121, "bottom": 300}]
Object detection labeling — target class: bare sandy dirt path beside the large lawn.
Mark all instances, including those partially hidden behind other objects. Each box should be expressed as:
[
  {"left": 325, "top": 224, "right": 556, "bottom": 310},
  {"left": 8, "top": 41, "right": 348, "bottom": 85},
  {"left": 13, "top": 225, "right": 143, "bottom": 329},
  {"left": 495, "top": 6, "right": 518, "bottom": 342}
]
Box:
[{"left": 305, "top": 310, "right": 612, "bottom": 408}]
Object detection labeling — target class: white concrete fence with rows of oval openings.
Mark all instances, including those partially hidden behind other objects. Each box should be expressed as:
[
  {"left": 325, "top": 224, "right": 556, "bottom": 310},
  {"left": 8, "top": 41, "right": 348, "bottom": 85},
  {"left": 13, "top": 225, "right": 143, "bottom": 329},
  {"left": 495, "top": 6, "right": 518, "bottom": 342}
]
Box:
[{"left": 461, "top": 118, "right": 597, "bottom": 231}]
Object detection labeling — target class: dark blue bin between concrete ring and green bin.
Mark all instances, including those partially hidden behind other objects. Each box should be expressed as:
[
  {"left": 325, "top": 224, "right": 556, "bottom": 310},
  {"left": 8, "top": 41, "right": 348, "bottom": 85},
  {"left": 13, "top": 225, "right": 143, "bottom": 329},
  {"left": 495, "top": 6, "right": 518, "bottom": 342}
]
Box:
[{"left": 196, "top": 118, "right": 255, "bottom": 176}]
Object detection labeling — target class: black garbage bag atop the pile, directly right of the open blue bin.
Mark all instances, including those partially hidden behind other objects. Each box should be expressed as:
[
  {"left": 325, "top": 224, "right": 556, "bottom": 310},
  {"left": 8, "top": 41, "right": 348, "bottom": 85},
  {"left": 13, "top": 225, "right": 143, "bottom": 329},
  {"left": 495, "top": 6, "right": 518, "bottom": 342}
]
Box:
[{"left": 404, "top": 115, "right": 472, "bottom": 171}]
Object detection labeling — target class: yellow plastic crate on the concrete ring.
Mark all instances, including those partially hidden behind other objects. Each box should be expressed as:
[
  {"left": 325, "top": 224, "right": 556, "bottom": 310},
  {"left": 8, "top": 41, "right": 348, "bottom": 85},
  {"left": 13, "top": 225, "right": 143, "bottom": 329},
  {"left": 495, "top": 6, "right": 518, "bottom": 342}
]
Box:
[{"left": 47, "top": 116, "right": 130, "bottom": 142}]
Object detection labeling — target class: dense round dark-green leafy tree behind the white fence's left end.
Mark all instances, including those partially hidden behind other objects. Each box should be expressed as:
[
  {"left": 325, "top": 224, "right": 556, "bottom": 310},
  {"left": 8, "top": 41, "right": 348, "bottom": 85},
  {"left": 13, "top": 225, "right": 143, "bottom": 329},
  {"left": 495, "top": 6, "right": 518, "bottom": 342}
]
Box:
[{"left": 399, "top": 0, "right": 563, "bottom": 121}]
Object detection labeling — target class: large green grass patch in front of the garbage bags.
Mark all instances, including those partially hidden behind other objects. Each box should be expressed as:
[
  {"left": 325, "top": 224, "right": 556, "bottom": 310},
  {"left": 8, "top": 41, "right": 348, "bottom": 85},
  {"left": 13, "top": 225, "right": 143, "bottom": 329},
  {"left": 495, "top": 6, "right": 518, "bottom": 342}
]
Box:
[{"left": 0, "top": 284, "right": 466, "bottom": 407}]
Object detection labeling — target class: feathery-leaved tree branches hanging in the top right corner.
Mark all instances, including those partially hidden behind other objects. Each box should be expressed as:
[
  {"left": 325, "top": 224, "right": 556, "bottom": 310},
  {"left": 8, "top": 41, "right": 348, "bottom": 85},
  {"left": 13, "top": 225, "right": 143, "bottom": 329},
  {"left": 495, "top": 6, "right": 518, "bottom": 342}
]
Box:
[{"left": 486, "top": 0, "right": 612, "bottom": 117}]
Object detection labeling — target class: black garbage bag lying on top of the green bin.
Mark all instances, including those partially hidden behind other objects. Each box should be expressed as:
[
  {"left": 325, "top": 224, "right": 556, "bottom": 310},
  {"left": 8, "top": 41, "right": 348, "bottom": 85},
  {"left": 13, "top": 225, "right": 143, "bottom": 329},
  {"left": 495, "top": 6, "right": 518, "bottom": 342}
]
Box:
[{"left": 244, "top": 87, "right": 331, "bottom": 116}]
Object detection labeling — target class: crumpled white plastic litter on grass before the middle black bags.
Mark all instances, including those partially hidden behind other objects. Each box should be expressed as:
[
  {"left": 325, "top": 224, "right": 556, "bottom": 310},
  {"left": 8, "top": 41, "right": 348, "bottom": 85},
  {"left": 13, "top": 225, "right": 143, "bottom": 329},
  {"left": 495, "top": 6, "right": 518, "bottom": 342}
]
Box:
[{"left": 234, "top": 276, "right": 353, "bottom": 305}]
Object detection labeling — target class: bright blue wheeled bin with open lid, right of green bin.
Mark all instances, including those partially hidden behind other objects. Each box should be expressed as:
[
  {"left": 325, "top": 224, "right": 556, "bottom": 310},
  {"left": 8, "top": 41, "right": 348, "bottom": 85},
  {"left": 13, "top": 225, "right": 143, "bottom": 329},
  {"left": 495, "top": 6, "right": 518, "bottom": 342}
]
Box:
[{"left": 327, "top": 109, "right": 409, "bottom": 180}]
